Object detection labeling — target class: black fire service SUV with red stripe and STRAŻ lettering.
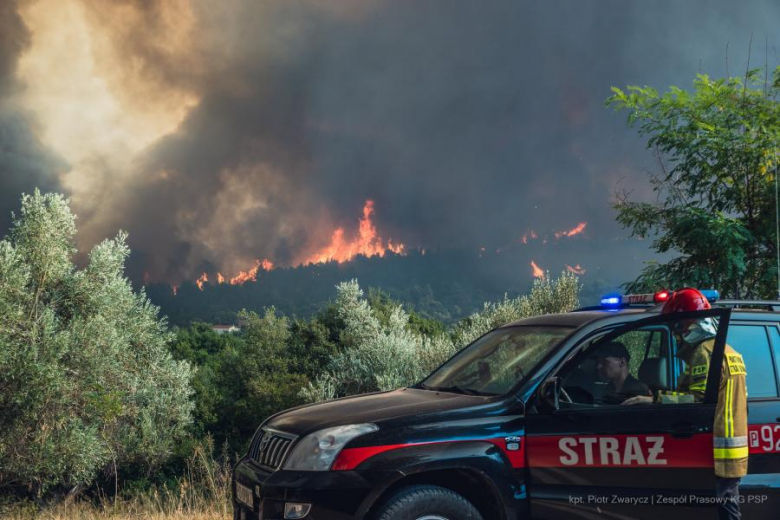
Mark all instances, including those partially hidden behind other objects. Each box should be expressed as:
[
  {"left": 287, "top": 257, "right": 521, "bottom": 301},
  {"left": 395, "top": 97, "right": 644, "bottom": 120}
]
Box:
[{"left": 233, "top": 291, "right": 780, "bottom": 520}]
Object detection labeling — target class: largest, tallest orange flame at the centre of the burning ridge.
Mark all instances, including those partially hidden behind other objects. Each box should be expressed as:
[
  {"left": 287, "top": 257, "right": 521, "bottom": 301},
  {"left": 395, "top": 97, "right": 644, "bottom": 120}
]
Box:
[{"left": 302, "top": 200, "right": 406, "bottom": 265}]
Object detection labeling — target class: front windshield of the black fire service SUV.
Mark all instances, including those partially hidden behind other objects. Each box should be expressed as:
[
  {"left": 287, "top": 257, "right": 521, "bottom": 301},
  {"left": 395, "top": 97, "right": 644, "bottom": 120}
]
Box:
[{"left": 418, "top": 326, "right": 572, "bottom": 395}]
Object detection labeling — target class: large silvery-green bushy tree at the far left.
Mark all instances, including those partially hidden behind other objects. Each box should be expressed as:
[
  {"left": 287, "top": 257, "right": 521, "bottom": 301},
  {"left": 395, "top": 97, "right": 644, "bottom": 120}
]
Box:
[{"left": 0, "top": 191, "right": 192, "bottom": 495}]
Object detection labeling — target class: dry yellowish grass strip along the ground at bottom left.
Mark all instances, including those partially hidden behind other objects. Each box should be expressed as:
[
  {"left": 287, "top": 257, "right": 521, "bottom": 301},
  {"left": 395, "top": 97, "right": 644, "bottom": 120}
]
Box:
[{"left": 0, "top": 443, "right": 233, "bottom": 520}]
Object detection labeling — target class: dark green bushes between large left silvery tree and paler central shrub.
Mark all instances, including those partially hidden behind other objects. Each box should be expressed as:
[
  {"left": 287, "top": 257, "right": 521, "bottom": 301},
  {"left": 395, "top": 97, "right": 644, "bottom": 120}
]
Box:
[{"left": 171, "top": 308, "right": 310, "bottom": 457}]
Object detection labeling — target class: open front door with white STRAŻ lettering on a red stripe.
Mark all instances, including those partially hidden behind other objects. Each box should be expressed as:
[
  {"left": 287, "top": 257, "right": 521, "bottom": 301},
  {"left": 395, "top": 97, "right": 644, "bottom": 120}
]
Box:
[{"left": 526, "top": 309, "right": 731, "bottom": 520}]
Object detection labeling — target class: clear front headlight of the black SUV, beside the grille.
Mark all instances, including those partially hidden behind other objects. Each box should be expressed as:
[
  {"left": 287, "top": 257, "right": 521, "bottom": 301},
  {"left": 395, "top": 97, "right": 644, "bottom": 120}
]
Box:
[{"left": 284, "top": 423, "right": 379, "bottom": 471}]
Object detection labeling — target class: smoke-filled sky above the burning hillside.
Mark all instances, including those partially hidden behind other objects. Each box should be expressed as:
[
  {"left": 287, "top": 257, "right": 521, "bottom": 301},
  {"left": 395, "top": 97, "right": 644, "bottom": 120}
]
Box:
[{"left": 0, "top": 0, "right": 780, "bottom": 282}]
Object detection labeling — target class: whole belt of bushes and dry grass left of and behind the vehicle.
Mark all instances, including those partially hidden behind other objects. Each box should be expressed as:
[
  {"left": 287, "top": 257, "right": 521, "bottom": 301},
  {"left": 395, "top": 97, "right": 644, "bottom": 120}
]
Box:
[{"left": 0, "top": 192, "right": 580, "bottom": 519}]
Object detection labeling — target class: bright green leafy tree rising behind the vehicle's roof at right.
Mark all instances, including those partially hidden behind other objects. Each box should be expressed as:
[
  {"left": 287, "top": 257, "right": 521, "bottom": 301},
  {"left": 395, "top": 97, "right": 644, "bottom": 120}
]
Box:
[{"left": 607, "top": 67, "right": 780, "bottom": 298}]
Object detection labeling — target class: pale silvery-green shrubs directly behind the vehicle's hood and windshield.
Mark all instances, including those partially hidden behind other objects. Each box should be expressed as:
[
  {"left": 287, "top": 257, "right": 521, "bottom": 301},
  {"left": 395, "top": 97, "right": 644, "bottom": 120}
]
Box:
[{"left": 302, "top": 273, "right": 580, "bottom": 401}]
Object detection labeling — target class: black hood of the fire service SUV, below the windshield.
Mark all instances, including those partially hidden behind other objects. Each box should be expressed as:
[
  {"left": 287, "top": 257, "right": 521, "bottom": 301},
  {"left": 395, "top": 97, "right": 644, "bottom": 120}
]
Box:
[{"left": 265, "top": 388, "right": 485, "bottom": 436}]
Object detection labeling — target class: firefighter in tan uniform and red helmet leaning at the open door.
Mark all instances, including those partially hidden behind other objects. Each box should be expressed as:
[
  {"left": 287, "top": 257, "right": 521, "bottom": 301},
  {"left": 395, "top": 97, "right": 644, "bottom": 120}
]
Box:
[{"left": 623, "top": 288, "right": 748, "bottom": 520}]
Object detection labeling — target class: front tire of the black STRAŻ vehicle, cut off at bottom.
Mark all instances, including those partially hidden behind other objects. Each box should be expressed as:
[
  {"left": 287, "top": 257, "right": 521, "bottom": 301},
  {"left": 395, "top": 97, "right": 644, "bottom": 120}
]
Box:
[{"left": 374, "top": 486, "right": 482, "bottom": 520}]
